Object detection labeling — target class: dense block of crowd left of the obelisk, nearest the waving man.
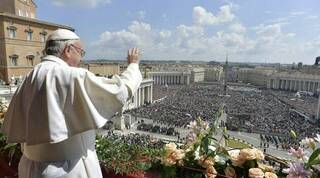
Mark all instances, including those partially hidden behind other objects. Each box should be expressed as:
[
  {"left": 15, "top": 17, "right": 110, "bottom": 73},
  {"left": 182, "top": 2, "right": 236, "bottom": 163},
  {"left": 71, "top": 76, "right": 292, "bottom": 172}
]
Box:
[{"left": 131, "top": 85, "right": 219, "bottom": 128}]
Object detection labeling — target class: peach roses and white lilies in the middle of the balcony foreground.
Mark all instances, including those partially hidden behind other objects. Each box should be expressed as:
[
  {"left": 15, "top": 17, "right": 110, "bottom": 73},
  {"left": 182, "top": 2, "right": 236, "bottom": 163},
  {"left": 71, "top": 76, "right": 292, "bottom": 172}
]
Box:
[{"left": 161, "top": 109, "right": 277, "bottom": 178}]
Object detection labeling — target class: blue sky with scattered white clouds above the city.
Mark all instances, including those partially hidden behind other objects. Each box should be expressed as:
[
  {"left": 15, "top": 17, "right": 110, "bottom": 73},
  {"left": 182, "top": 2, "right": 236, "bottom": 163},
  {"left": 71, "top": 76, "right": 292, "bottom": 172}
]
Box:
[{"left": 35, "top": 0, "right": 320, "bottom": 64}]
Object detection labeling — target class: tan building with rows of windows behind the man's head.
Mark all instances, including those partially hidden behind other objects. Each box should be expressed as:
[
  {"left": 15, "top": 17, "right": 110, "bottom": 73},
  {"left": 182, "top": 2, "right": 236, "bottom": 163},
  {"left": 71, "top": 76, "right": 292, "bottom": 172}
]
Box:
[{"left": 0, "top": 0, "right": 74, "bottom": 84}]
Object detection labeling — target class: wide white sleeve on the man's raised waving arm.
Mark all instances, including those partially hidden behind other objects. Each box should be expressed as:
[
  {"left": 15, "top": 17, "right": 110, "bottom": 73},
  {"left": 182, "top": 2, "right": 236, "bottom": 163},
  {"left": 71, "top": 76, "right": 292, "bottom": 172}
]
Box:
[{"left": 76, "top": 64, "right": 142, "bottom": 119}]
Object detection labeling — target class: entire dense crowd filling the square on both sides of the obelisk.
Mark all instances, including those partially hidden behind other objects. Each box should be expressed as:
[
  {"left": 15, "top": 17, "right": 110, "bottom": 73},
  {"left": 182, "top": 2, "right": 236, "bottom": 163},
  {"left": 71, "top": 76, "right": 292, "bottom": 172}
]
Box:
[{"left": 130, "top": 84, "right": 320, "bottom": 142}]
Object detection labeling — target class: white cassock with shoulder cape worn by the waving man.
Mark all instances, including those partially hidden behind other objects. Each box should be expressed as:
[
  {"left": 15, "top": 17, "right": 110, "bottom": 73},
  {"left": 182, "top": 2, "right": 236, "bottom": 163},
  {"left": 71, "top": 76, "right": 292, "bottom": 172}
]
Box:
[{"left": 3, "top": 56, "right": 142, "bottom": 178}]
